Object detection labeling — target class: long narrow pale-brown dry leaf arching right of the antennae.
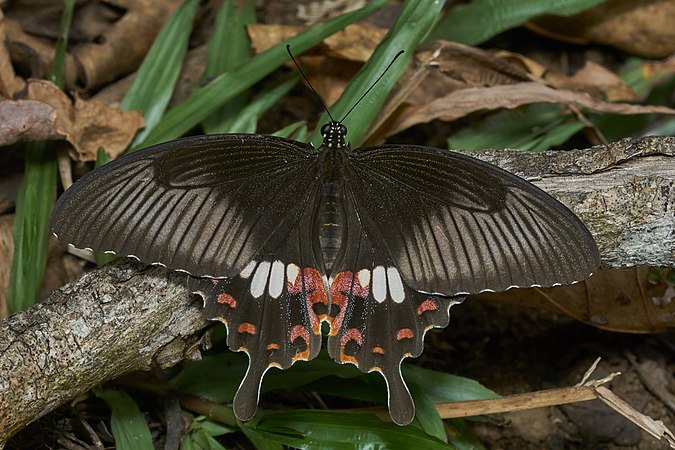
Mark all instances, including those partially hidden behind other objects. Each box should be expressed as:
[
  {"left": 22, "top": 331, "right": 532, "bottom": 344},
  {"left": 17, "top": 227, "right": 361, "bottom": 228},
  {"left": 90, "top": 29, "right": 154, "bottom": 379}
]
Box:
[{"left": 386, "top": 82, "right": 675, "bottom": 136}]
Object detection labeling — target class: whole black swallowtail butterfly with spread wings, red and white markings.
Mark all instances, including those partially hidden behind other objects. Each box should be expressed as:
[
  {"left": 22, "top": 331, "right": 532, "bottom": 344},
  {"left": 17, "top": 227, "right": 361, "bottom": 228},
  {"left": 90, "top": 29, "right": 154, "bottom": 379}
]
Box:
[{"left": 50, "top": 122, "right": 599, "bottom": 424}]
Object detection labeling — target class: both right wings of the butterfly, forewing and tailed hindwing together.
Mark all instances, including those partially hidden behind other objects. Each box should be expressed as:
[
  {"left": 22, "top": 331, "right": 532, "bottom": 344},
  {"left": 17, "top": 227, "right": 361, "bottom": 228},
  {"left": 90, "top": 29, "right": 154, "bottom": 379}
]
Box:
[{"left": 328, "top": 146, "right": 599, "bottom": 424}]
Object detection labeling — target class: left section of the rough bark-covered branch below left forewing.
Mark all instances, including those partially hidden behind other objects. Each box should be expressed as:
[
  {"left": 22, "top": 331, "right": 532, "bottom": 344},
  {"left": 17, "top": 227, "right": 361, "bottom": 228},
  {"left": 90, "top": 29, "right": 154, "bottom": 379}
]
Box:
[{"left": 0, "top": 259, "right": 208, "bottom": 447}]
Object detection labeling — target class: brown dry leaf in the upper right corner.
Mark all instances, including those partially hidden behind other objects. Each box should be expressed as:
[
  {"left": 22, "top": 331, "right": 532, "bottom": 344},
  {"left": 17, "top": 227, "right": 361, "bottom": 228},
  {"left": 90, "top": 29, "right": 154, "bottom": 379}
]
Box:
[{"left": 527, "top": 0, "right": 675, "bottom": 58}]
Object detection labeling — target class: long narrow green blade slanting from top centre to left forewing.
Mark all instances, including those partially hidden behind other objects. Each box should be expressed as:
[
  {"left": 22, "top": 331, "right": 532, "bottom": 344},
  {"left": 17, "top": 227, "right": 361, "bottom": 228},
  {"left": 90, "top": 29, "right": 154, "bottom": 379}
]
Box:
[{"left": 137, "top": 0, "right": 387, "bottom": 147}]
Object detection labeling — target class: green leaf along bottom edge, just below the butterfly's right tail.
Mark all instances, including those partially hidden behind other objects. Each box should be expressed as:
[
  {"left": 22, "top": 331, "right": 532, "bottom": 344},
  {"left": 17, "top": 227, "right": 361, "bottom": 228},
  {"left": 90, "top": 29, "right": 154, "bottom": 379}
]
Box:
[{"left": 248, "top": 410, "right": 451, "bottom": 450}]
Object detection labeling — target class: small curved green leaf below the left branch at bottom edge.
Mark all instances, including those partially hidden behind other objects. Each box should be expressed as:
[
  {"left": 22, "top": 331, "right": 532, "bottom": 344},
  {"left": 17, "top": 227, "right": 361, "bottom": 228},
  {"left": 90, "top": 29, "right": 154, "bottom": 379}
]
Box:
[{"left": 93, "top": 388, "right": 154, "bottom": 450}]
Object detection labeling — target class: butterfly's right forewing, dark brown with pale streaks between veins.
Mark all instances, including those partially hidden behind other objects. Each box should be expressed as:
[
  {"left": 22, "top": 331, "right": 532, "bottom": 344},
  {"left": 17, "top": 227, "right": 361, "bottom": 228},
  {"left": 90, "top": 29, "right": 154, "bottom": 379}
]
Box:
[{"left": 345, "top": 146, "right": 599, "bottom": 295}]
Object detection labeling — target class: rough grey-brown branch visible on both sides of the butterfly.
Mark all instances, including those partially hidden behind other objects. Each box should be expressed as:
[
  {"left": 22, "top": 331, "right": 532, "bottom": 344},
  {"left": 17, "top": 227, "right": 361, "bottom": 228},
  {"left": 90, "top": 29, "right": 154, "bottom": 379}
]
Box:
[{"left": 0, "top": 137, "right": 675, "bottom": 446}]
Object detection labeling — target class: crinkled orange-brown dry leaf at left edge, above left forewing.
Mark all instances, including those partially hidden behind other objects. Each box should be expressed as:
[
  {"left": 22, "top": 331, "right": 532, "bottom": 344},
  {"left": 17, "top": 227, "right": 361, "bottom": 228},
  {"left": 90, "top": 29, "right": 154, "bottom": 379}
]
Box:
[{"left": 0, "top": 80, "right": 143, "bottom": 161}]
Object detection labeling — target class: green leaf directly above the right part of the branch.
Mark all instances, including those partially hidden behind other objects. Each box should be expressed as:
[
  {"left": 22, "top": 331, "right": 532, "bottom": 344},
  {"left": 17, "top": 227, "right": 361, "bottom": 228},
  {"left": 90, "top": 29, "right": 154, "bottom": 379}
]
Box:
[{"left": 448, "top": 103, "right": 584, "bottom": 151}]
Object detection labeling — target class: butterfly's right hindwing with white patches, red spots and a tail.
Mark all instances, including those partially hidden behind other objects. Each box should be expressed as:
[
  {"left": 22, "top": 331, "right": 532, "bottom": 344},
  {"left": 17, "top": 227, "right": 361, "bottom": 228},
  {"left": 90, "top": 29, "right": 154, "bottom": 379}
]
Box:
[{"left": 328, "top": 195, "right": 463, "bottom": 425}]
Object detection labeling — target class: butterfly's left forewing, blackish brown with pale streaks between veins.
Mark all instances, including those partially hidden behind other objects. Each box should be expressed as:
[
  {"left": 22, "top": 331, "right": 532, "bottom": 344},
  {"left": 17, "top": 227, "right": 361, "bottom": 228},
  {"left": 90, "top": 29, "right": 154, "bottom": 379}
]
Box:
[{"left": 50, "top": 135, "right": 319, "bottom": 277}]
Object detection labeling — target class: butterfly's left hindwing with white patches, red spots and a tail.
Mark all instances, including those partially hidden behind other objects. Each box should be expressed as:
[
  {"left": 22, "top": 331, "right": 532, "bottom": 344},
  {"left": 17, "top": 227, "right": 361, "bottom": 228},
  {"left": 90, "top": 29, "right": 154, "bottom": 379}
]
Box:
[{"left": 189, "top": 177, "right": 328, "bottom": 420}]
